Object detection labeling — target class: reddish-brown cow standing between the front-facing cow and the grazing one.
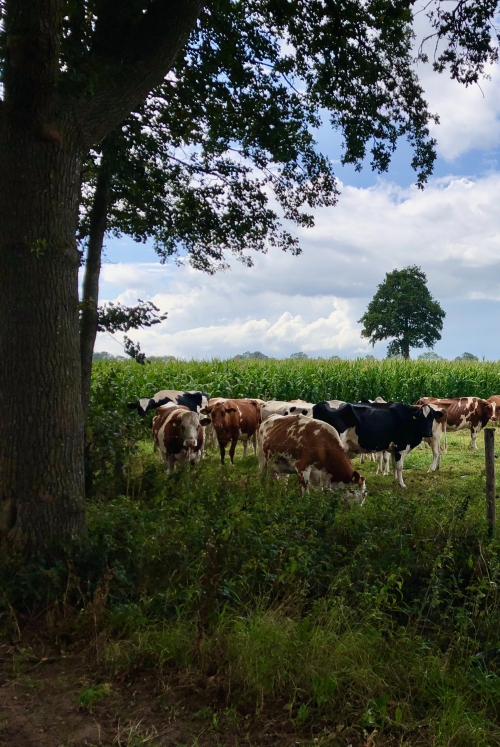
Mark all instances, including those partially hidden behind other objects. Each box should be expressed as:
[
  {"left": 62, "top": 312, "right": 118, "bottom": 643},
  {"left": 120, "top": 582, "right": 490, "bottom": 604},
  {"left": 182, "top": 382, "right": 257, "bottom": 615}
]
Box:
[{"left": 202, "top": 399, "right": 262, "bottom": 466}]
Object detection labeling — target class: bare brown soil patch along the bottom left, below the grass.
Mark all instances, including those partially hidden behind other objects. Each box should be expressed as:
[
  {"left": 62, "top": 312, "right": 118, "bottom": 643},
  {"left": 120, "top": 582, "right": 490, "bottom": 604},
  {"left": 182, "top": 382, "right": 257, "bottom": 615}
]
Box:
[{"left": 0, "top": 642, "right": 352, "bottom": 747}]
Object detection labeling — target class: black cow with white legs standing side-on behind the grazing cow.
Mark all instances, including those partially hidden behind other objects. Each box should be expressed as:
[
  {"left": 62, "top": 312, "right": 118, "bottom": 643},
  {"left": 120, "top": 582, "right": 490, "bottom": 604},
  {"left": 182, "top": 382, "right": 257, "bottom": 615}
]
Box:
[{"left": 313, "top": 402, "right": 443, "bottom": 488}]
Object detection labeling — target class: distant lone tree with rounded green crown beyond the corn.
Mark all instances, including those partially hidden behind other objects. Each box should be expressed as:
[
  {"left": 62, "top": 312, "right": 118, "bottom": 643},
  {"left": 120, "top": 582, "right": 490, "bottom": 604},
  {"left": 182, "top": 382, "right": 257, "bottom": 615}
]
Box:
[{"left": 358, "top": 265, "right": 445, "bottom": 359}]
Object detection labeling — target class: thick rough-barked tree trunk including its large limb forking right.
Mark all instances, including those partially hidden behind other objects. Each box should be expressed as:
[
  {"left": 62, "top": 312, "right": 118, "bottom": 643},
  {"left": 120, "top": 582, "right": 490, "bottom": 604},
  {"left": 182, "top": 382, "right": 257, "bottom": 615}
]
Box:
[{"left": 0, "top": 0, "right": 202, "bottom": 552}]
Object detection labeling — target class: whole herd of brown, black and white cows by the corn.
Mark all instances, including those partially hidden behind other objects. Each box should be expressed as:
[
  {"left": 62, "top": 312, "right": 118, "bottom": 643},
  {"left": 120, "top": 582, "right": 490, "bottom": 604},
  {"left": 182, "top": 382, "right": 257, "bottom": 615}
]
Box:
[{"left": 129, "top": 390, "right": 500, "bottom": 501}]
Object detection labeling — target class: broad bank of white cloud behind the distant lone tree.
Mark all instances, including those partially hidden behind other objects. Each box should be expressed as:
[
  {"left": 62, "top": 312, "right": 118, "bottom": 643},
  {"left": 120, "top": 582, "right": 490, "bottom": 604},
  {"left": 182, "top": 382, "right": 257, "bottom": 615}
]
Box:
[{"left": 98, "top": 174, "right": 500, "bottom": 358}]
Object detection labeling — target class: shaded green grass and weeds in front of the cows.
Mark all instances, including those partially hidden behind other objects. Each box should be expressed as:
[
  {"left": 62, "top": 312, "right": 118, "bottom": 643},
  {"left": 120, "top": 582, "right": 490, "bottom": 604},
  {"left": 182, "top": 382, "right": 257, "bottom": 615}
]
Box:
[{"left": 0, "top": 426, "right": 500, "bottom": 747}]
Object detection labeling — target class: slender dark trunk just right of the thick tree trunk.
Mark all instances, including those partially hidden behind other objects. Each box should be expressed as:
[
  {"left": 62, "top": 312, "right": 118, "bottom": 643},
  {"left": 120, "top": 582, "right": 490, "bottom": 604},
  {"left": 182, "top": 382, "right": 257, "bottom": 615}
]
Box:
[{"left": 80, "top": 141, "right": 111, "bottom": 420}]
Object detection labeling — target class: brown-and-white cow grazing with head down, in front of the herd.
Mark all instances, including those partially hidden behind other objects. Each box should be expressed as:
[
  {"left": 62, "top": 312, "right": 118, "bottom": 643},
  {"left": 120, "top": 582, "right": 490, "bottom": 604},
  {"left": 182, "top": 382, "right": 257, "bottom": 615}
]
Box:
[{"left": 259, "top": 415, "right": 366, "bottom": 503}]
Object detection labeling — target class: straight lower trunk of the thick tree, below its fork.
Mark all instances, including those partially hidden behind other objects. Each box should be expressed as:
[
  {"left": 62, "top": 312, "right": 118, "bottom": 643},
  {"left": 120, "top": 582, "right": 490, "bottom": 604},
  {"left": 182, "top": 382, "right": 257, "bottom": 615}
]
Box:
[{"left": 0, "top": 131, "right": 85, "bottom": 552}]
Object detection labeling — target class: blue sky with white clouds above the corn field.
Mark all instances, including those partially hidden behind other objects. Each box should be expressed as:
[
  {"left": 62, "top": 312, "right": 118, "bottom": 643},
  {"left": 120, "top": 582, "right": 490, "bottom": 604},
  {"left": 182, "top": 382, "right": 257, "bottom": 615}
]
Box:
[{"left": 96, "top": 19, "right": 500, "bottom": 360}]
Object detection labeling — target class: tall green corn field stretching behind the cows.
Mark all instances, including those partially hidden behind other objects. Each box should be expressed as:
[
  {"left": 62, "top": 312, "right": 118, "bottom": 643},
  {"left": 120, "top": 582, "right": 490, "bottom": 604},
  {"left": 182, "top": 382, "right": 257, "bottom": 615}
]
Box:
[{"left": 92, "top": 359, "right": 500, "bottom": 406}]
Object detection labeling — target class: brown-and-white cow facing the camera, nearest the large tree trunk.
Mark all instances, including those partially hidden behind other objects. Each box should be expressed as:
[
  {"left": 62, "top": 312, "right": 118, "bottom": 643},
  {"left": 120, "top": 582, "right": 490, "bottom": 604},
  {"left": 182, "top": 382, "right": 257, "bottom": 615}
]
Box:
[{"left": 153, "top": 403, "right": 210, "bottom": 475}]
